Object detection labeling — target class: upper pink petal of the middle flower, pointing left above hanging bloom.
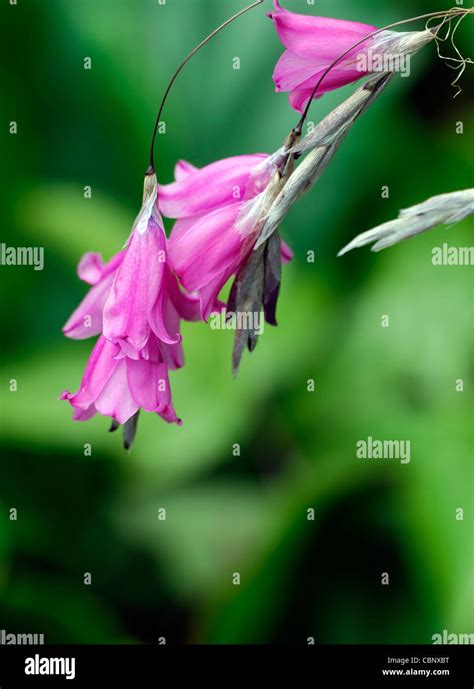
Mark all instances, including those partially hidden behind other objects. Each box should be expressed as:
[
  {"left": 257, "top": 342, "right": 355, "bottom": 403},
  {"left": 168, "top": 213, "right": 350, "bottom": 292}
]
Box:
[{"left": 158, "top": 153, "right": 268, "bottom": 218}]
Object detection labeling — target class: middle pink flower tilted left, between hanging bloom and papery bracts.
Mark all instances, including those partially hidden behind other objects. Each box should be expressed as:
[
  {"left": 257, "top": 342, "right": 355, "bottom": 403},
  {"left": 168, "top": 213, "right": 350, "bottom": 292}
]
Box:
[{"left": 158, "top": 154, "right": 292, "bottom": 320}]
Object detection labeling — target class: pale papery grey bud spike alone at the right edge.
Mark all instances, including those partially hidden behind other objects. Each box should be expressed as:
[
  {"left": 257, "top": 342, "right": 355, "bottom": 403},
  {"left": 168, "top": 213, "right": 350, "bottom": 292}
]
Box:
[{"left": 338, "top": 189, "right": 474, "bottom": 256}]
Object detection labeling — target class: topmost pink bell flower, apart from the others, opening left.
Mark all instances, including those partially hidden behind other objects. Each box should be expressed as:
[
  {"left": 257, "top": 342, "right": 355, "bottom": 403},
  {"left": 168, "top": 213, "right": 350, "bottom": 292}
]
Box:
[{"left": 267, "top": 0, "right": 377, "bottom": 112}]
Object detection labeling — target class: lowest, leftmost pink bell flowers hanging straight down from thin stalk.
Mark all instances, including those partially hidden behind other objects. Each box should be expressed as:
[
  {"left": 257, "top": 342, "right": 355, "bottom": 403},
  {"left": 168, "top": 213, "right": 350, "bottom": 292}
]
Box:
[{"left": 61, "top": 175, "right": 199, "bottom": 424}]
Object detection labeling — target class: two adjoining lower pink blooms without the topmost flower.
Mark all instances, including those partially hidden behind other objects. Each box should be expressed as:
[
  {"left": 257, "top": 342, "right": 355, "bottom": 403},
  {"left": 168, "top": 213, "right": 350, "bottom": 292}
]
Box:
[{"left": 61, "top": 154, "right": 291, "bottom": 440}]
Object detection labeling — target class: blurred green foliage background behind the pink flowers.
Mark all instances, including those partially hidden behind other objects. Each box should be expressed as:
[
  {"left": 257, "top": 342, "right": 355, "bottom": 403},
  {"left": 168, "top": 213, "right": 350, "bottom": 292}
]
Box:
[{"left": 0, "top": 0, "right": 474, "bottom": 643}]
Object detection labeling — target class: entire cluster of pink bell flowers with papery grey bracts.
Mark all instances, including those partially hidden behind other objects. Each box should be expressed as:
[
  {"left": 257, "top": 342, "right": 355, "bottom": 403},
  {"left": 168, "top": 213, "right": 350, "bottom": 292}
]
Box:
[{"left": 61, "top": 0, "right": 444, "bottom": 446}]
